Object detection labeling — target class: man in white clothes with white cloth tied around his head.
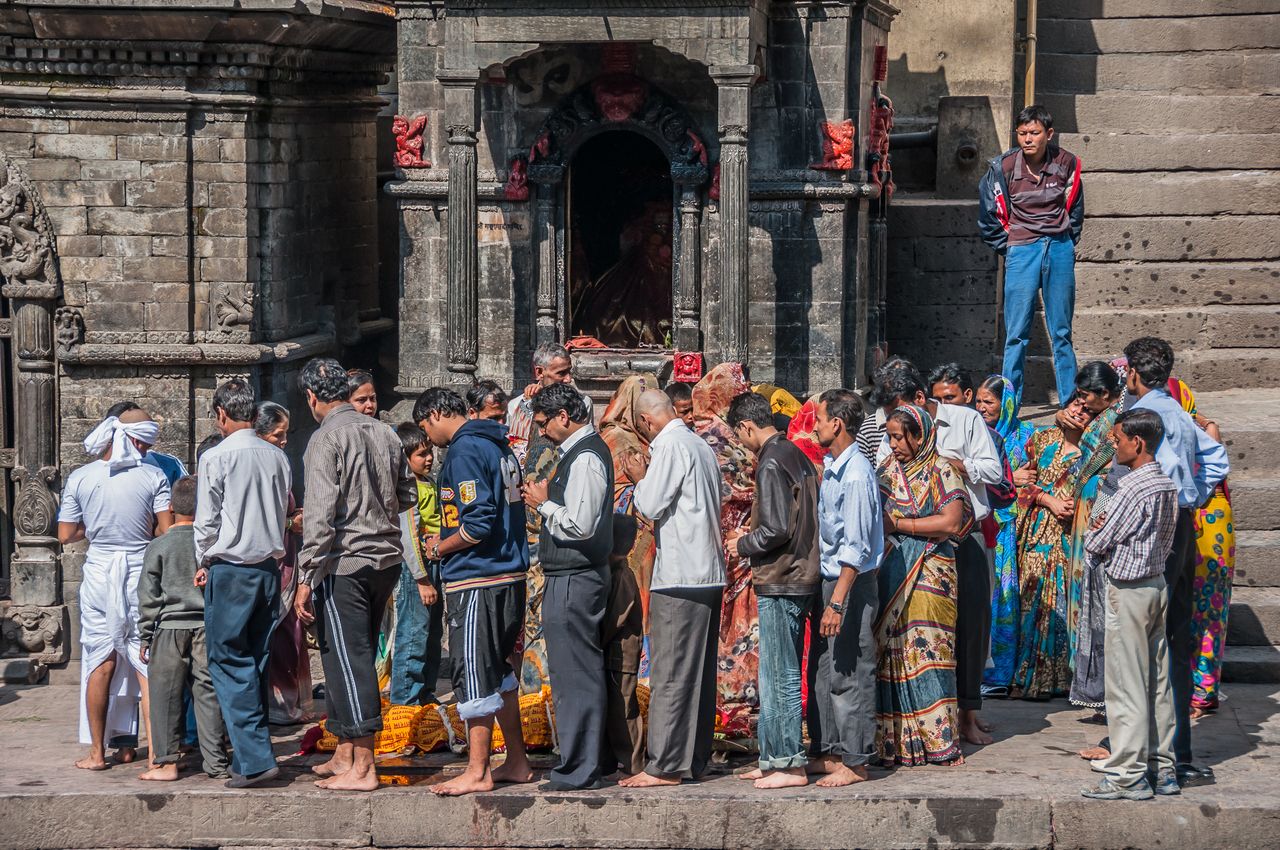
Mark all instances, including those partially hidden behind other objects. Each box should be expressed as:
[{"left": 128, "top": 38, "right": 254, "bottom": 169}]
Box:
[{"left": 58, "top": 410, "right": 173, "bottom": 771}]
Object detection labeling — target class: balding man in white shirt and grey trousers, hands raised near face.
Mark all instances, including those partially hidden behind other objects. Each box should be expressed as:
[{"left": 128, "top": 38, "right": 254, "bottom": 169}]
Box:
[{"left": 621, "top": 389, "right": 724, "bottom": 787}]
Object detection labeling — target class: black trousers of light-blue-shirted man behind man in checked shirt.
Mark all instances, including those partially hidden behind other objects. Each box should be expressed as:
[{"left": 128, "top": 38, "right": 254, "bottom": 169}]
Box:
[{"left": 1165, "top": 508, "right": 1196, "bottom": 764}]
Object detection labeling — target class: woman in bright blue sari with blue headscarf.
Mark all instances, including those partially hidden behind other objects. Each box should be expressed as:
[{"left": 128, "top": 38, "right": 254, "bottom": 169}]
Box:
[{"left": 974, "top": 375, "right": 1036, "bottom": 695}]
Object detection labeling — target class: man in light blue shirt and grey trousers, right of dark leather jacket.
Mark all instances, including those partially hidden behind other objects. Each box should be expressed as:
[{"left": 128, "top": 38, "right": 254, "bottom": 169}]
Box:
[{"left": 808, "top": 389, "right": 884, "bottom": 787}]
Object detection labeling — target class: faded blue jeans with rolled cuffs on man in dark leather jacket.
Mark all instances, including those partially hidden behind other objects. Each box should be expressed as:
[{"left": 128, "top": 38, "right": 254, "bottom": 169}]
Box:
[{"left": 756, "top": 594, "right": 813, "bottom": 771}]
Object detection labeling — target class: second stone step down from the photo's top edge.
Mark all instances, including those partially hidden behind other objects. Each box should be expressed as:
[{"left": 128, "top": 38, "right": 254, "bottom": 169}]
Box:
[{"left": 1037, "top": 9, "right": 1280, "bottom": 54}]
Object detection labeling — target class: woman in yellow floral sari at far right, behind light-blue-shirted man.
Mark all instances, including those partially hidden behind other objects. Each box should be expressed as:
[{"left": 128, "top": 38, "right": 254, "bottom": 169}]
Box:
[{"left": 1169, "top": 378, "right": 1235, "bottom": 717}]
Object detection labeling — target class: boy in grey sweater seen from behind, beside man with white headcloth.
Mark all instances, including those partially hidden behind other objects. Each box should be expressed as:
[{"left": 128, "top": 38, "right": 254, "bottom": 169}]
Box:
[{"left": 138, "top": 475, "right": 230, "bottom": 782}]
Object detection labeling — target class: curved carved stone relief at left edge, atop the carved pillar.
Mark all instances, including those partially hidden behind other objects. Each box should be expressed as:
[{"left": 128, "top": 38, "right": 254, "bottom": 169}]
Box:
[{"left": 0, "top": 156, "right": 61, "bottom": 285}]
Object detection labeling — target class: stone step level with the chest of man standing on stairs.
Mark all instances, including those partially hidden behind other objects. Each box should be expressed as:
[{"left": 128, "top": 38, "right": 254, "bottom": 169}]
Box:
[{"left": 1085, "top": 171, "right": 1280, "bottom": 217}]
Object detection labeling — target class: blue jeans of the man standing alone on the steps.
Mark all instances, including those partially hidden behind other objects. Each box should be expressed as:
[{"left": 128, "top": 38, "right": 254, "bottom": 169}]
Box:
[{"left": 1001, "top": 233, "right": 1075, "bottom": 405}]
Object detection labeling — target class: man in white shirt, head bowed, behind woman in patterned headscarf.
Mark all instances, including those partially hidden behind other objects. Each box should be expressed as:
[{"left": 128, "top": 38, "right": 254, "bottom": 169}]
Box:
[{"left": 876, "top": 369, "right": 1005, "bottom": 744}]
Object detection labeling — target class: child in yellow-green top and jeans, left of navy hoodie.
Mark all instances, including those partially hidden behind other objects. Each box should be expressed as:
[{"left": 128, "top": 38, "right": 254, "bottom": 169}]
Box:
[{"left": 390, "top": 422, "right": 444, "bottom": 705}]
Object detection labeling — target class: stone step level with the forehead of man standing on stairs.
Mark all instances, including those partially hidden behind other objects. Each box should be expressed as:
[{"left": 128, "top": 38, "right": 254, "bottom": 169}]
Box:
[{"left": 1041, "top": 93, "right": 1280, "bottom": 134}]
